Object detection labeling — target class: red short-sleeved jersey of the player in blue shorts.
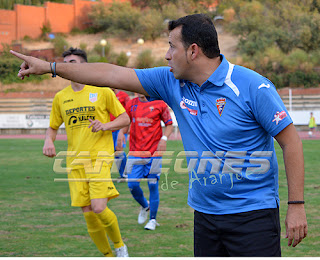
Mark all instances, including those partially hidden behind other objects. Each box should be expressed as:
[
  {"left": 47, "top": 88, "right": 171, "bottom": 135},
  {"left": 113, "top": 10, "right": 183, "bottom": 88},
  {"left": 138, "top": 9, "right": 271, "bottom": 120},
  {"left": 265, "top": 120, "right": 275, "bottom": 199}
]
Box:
[{"left": 126, "top": 97, "right": 172, "bottom": 154}]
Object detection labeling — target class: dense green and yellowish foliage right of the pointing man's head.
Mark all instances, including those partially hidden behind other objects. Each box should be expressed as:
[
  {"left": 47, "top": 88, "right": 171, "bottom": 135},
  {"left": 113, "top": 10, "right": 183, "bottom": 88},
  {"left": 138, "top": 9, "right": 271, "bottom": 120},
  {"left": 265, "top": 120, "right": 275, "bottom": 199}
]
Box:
[{"left": 218, "top": 0, "right": 320, "bottom": 87}]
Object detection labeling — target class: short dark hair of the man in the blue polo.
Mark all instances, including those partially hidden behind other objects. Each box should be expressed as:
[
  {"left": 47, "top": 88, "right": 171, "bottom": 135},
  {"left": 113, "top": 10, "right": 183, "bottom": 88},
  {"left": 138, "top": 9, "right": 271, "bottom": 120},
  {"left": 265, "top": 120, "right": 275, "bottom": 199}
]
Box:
[{"left": 168, "top": 14, "right": 220, "bottom": 59}]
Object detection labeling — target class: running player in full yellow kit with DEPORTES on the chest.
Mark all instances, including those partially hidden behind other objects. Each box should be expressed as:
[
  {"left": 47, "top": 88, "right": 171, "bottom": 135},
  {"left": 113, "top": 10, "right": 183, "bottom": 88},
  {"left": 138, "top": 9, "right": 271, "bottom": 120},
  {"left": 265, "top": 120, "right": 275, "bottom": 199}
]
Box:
[{"left": 43, "top": 48, "right": 130, "bottom": 257}]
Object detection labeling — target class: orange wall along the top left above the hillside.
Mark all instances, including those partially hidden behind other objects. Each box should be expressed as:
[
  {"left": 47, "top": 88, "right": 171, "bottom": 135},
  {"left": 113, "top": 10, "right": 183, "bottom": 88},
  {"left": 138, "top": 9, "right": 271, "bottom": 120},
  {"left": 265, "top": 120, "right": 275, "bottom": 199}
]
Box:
[{"left": 0, "top": 0, "right": 129, "bottom": 51}]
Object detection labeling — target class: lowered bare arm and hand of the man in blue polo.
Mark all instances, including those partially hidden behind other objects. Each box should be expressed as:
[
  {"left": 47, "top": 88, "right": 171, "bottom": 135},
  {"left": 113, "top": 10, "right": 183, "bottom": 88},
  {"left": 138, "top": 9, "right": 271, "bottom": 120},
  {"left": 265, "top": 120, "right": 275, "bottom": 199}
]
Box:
[{"left": 275, "top": 124, "right": 308, "bottom": 247}]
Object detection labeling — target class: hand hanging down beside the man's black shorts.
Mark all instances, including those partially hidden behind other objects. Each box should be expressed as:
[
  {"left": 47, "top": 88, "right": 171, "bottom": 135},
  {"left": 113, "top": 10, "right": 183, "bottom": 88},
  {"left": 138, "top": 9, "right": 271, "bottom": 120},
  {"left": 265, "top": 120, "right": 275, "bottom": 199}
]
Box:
[{"left": 285, "top": 204, "right": 308, "bottom": 247}]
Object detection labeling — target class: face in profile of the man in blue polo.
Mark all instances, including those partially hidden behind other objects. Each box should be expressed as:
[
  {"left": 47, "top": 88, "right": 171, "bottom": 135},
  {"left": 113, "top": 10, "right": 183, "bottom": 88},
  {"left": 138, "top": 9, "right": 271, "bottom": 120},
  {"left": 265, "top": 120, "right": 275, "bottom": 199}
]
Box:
[{"left": 165, "top": 26, "right": 190, "bottom": 79}]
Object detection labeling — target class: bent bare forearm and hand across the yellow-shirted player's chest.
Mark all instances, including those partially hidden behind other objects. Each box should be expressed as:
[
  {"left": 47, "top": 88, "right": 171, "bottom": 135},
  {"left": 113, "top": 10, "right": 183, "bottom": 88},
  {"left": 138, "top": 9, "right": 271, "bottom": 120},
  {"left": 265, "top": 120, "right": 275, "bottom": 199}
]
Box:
[{"left": 88, "top": 112, "right": 130, "bottom": 132}]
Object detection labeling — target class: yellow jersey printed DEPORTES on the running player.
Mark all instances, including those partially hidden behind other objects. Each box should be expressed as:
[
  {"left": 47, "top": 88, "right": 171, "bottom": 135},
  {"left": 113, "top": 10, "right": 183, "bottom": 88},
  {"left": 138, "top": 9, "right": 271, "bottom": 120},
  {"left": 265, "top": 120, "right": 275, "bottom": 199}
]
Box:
[{"left": 50, "top": 85, "right": 125, "bottom": 168}]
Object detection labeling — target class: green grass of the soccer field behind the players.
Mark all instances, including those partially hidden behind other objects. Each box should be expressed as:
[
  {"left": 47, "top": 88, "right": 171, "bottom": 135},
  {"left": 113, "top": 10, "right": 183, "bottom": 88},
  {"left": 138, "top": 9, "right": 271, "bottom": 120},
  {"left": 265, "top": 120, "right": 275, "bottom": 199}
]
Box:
[{"left": 0, "top": 139, "right": 320, "bottom": 257}]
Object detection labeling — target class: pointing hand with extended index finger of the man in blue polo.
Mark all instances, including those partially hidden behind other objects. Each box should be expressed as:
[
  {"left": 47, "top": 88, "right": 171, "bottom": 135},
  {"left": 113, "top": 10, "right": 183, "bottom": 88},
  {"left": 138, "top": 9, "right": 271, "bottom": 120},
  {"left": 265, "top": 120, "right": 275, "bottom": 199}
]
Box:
[{"left": 10, "top": 51, "right": 51, "bottom": 79}]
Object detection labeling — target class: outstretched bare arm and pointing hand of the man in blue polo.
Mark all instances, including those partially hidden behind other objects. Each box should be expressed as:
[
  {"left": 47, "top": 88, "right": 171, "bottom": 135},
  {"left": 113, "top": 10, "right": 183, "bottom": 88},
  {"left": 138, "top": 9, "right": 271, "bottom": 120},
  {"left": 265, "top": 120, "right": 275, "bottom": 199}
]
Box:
[{"left": 10, "top": 51, "right": 148, "bottom": 95}]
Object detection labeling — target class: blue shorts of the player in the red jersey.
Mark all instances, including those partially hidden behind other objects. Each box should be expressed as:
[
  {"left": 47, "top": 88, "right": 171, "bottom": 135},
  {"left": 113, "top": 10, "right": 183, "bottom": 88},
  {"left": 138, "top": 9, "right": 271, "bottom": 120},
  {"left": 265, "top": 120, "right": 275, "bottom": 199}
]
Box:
[{"left": 124, "top": 156, "right": 162, "bottom": 180}]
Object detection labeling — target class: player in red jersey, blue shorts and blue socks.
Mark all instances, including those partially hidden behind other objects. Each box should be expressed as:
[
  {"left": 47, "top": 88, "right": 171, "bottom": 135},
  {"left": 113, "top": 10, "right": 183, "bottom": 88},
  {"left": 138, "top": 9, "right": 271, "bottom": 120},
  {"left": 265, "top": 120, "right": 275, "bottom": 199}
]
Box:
[{"left": 121, "top": 94, "right": 173, "bottom": 230}]
